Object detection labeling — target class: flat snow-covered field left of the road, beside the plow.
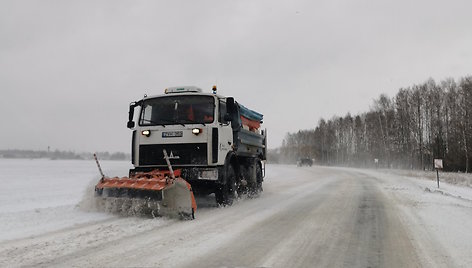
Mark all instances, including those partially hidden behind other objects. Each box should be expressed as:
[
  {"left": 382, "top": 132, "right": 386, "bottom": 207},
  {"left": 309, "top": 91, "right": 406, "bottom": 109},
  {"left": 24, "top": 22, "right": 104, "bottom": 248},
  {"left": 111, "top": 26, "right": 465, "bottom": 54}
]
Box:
[{"left": 0, "top": 159, "right": 130, "bottom": 242}]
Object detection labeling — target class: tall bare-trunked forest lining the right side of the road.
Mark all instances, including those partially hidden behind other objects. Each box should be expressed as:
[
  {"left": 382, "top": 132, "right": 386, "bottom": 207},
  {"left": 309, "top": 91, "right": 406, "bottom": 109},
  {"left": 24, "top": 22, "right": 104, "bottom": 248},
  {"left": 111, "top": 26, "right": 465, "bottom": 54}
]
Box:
[{"left": 279, "top": 76, "right": 472, "bottom": 172}]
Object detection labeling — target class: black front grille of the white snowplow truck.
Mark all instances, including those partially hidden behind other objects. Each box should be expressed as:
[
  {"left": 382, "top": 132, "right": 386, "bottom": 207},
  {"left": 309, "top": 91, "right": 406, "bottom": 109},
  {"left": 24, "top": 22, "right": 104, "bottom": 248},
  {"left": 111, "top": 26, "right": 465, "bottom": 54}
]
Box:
[{"left": 139, "top": 143, "right": 208, "bottom": 166}]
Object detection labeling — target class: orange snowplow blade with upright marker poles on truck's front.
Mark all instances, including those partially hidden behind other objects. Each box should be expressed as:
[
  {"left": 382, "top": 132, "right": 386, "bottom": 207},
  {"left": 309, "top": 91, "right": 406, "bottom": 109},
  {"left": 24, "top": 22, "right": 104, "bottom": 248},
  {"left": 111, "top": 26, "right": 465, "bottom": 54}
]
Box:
[{"left": 94, "top": 149, "right": 197, "bottom": 219}]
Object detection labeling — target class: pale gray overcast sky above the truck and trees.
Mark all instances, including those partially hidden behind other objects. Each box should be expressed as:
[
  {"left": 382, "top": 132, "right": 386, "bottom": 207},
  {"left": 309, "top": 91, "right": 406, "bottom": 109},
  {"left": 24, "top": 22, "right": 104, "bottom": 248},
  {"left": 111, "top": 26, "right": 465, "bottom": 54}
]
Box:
[{"left": 0, "top": 0, "right": 472, "bottom": 152}]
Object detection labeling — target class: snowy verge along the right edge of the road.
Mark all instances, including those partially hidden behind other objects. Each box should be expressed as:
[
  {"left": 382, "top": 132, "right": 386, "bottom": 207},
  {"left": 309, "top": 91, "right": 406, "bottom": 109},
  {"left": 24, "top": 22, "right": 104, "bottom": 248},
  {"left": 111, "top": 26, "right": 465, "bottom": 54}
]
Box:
[{"left": 350, "top": 166, "right": 472, "bottom": 267}]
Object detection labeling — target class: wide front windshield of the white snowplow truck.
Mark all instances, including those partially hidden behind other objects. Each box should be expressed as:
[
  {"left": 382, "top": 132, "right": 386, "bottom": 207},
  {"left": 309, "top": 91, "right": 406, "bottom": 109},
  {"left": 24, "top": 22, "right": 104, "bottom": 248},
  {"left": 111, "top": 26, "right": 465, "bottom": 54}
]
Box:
[{"left": 139, "top": 96, "right": 215, "bottom": 126}]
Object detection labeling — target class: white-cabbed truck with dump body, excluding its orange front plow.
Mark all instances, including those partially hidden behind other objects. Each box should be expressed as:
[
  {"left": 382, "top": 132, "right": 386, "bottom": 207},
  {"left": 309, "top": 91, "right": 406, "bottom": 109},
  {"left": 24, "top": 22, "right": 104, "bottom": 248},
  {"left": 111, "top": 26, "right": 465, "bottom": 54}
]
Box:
[{"left": 127, "top": 86, "right": 267, "bottom": 205}]
